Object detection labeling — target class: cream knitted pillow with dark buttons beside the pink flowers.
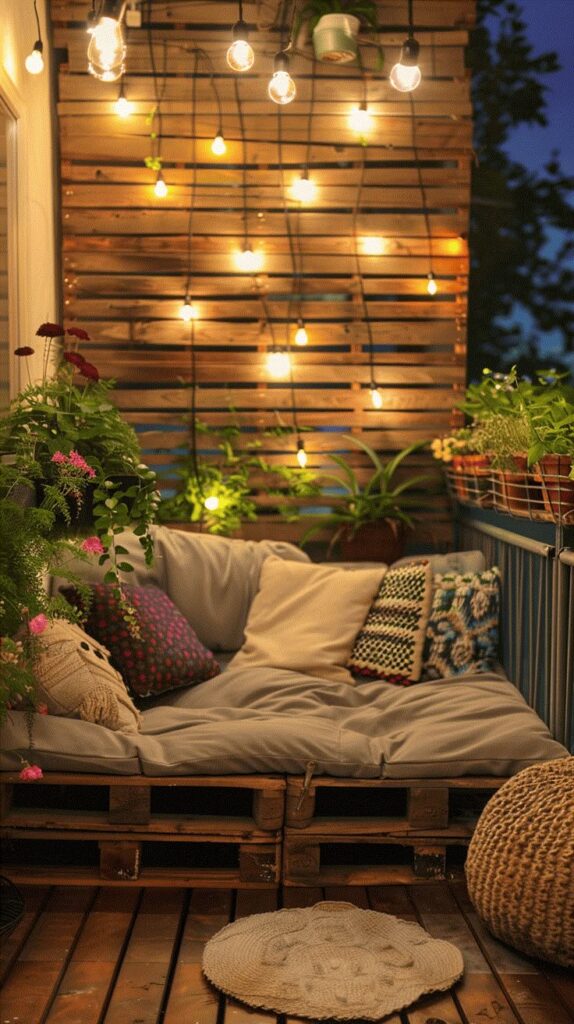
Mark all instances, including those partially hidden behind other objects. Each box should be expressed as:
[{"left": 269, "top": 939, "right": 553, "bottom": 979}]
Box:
[{"left": 34, "top": 618, "right": 140, "bottom": 732}]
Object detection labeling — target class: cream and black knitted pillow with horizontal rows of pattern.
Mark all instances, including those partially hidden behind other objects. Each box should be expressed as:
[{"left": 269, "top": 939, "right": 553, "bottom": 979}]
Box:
[{"left": 347, "top": 563, "right": 433, "bottom": 686}]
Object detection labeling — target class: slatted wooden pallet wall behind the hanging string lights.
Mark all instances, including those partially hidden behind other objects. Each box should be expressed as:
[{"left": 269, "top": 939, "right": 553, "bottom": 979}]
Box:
[{"left": 50, "top": 0, "right": 475, "bottom": 543}]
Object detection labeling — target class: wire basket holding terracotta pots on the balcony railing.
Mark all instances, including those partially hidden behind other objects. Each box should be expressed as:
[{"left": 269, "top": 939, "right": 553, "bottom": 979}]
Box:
[{"left": 445, "top": 455, "right": 574, "bottom": 526}]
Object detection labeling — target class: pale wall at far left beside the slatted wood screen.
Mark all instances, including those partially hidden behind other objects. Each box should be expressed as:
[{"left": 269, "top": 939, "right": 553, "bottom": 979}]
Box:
[{"left": 0, "top": 0, "right": 59, "bottom": 393}]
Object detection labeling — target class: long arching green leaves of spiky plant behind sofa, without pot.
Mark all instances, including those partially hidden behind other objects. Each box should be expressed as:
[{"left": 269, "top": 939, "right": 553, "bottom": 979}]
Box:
[{"left": 301, "top": 434, "right": 432, "bottom": 547}]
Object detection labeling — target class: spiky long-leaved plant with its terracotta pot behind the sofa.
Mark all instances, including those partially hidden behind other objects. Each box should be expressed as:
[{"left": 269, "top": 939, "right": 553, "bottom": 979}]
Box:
[{"left": 301, "top": 434, "right": 432, "bottom": 562}]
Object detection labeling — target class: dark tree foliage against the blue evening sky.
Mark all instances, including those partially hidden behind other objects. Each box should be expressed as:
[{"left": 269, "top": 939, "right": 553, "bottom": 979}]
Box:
[{"left": 469, "top": 0, "right": 574, "bottom": 379}]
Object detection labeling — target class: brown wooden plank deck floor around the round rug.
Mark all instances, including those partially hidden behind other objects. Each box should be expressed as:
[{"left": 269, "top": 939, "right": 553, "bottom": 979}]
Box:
[{"left": 0, "top": 883, "right": 574, "bottom": 1024}]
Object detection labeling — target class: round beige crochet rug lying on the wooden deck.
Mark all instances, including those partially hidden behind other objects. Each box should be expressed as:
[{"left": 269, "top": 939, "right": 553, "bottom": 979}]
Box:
[{"left": 202, "top": 902, "right": 463, "bottom": 1020}]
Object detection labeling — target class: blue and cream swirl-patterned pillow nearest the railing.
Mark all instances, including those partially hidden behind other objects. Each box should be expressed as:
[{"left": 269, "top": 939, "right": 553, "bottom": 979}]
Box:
[{"left": 423, "top": 567, "right": 500, "bottom": 679}]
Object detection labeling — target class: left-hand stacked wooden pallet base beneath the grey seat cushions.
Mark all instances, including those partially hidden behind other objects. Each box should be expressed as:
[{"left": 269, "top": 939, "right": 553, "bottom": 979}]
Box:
[{"left": 0, "top": 772, "right": 285, "bottom": 889}]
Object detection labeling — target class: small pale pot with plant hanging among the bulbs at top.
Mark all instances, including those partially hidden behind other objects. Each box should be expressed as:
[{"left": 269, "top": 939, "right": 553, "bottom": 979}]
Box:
[{"left": 294, "top": 0, "right": 379, "bottom": 63}]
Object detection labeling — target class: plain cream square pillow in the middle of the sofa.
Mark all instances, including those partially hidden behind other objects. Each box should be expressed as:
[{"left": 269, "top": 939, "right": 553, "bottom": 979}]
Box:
[{"left": 231, "top": 556, "right": 386, "bottom": 684}]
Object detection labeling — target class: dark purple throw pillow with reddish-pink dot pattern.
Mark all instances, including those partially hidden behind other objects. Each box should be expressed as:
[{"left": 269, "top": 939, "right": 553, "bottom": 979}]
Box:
[{"left": 62, "top": 584, "right": 220, "bottom": 697}]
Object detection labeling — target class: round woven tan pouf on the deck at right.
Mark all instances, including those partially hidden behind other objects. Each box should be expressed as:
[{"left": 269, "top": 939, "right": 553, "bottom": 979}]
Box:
[{"left": 466, "top": 758, "right": 574, "bottom": 967}]
